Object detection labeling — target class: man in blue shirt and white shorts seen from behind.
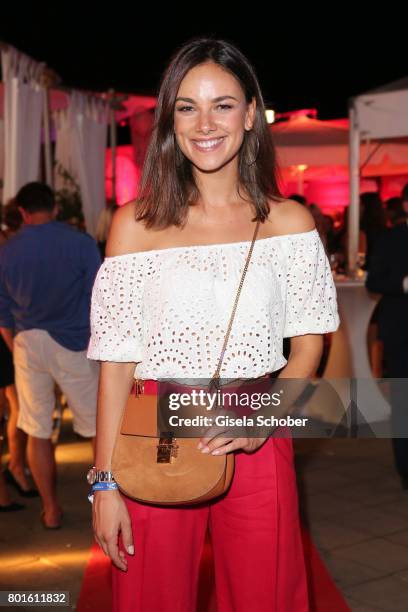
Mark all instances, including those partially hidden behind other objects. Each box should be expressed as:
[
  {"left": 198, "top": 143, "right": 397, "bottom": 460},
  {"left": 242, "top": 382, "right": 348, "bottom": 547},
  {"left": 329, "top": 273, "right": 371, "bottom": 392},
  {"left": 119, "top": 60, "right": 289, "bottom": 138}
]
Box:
[{"left": 0, "top": 182, "right": 101, "bottom": 528}]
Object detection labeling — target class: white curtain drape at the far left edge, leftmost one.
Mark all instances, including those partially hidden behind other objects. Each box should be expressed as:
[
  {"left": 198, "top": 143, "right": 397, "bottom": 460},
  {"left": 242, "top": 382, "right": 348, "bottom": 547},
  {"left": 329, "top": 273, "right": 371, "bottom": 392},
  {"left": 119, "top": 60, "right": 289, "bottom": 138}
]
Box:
[{"left": 1, "top": 46, "right": 45, "bottom": 203}]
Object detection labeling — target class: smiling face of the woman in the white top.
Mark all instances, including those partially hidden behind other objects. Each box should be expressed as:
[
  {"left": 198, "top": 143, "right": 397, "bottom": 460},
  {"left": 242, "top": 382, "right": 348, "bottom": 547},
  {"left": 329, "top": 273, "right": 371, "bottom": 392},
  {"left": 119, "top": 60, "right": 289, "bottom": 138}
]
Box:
[{"left": 174, "top": 62, "right": 256, "bottom": 172}]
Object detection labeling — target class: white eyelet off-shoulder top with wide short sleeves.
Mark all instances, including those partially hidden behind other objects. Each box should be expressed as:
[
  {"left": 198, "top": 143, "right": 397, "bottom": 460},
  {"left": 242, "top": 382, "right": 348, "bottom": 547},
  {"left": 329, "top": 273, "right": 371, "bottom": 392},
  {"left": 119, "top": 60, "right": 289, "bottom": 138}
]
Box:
[{"left": 87, "top": 229, "right": 339, "bottom": 379}]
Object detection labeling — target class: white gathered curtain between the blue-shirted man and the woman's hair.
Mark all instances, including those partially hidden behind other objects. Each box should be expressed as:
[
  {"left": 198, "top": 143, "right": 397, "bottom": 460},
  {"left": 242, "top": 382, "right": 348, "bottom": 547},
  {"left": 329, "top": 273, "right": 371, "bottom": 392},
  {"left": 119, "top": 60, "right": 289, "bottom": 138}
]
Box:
[{"left": 54, "top": 91, "right": 109, "bottom": 237}]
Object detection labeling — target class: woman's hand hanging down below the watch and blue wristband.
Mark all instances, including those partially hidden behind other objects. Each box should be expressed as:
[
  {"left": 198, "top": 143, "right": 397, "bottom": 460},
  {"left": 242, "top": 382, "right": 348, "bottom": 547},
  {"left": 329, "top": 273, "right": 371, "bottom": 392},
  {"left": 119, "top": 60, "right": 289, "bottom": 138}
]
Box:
[{"left": 92, "top": 489, "right": 134, "bottom": 571}]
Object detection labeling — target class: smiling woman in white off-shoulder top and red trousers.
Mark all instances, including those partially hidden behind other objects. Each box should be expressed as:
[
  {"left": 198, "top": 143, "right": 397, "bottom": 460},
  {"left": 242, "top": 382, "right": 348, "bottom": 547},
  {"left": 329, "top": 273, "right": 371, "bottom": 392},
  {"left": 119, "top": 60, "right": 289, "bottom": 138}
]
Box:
[{"left": 88, "top": 39, "right": 338, "bottom": 612}]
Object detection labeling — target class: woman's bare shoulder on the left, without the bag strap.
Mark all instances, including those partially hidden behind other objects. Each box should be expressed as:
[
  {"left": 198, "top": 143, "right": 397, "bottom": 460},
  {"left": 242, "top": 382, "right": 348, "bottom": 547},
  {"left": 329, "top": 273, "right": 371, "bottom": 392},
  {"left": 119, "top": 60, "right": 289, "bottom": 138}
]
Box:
[{"left": 106, "top": 200, "right": 148, "bottom": 257}]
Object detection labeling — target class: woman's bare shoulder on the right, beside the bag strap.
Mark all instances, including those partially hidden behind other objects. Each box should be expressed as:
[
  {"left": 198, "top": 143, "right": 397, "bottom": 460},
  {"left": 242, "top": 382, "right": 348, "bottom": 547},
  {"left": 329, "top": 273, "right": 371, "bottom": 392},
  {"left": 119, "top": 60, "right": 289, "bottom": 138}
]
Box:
[{"left": 267, "top": 200, "right": 316, "bottom": 235}]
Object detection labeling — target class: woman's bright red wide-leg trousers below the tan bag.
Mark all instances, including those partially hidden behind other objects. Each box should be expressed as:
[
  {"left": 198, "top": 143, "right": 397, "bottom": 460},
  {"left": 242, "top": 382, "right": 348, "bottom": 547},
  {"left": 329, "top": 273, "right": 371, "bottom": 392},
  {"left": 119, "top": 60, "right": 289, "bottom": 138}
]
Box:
[{"left": 112, "top": 437, "right": 309, "bottom": 612}]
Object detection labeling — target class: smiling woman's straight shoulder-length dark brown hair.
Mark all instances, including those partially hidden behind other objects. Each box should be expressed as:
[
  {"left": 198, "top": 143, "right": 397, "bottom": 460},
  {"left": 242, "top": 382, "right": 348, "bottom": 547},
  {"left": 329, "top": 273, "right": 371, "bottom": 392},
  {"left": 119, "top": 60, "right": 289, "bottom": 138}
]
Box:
[{"left": 136, "top": 37, "right": 281, "bottom": 229}]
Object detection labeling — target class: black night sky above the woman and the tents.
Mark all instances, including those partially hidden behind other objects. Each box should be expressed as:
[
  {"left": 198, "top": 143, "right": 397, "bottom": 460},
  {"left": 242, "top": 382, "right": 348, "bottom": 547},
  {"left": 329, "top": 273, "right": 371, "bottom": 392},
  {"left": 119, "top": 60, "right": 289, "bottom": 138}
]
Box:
[{"left": 0, "top": 8, "right": 408, "bottom": 119}]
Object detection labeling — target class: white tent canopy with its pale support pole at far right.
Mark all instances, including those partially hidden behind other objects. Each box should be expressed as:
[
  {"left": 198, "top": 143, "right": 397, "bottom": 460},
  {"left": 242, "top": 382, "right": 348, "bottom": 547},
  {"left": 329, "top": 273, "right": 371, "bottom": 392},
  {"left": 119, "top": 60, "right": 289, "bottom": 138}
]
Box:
[{"left": 348, "top": 77, "right": 408, "bottom": 273}]
